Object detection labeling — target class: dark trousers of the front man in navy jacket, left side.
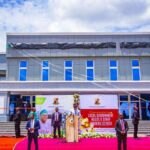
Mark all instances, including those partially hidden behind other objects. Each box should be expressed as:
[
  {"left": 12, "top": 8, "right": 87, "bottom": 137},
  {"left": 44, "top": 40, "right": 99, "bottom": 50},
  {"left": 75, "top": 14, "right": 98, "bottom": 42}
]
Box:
[{"left": 28, "top": 133, "right": 38, "bottom": 150}]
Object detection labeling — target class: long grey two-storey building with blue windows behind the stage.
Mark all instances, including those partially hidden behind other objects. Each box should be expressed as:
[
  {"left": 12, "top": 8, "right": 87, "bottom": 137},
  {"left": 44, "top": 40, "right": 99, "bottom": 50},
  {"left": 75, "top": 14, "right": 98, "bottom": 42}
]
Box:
[{"left": 0, "top": 33, "right": 150, "bottom": 121}]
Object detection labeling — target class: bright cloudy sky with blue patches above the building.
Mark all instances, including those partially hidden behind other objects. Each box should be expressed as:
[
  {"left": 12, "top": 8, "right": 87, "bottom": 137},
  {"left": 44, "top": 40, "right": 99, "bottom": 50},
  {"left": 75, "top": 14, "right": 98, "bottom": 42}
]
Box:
[{"left": 0, "top": 0, "right": 150, "bottom": 52}]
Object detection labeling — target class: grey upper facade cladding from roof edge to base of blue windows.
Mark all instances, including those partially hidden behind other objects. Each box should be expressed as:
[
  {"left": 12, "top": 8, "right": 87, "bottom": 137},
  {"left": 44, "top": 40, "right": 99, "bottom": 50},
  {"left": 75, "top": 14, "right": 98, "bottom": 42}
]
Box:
[{"left": 6, "top": 34, "right": 150, "bottom": 81}]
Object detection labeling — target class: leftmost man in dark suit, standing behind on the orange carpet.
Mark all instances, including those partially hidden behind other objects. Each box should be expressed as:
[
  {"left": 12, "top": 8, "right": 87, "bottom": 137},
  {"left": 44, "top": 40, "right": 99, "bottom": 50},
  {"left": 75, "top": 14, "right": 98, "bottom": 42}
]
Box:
[{"left": 14, "top": 107, "right": 21, "bottom": 138}]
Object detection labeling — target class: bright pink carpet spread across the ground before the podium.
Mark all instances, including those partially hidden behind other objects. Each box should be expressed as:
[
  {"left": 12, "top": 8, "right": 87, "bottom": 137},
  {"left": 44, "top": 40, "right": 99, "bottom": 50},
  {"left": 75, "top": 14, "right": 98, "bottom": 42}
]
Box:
[{"left": 15, "top": 137, "right": 150, "bottom": 150}]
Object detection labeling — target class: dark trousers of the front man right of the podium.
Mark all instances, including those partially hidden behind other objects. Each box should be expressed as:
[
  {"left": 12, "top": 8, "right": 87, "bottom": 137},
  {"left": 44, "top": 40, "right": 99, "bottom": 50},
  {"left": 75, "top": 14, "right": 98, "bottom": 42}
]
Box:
[{"left": 117, "top": 135, "right": 127, "bottom": 150}]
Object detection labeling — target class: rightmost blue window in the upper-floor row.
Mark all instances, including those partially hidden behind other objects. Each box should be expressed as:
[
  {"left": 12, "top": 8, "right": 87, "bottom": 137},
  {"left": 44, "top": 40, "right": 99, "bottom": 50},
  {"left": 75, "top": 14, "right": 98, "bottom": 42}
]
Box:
[{"left": 132, "top": 60, "right": 140, "bottom": 80}]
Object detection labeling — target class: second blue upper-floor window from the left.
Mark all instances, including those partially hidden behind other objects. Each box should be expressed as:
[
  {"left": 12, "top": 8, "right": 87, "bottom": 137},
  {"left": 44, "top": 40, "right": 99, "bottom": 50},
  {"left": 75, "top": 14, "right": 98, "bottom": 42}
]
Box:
[{"left": 42, "top": 60, "right": 49, "bottom": 81}]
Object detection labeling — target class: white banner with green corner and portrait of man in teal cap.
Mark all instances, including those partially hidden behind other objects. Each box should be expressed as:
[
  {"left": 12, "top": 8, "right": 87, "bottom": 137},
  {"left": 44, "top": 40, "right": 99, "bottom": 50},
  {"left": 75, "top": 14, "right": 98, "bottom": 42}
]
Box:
[{"left": 35, "top": 95, "right": 73, "bottom": 136}]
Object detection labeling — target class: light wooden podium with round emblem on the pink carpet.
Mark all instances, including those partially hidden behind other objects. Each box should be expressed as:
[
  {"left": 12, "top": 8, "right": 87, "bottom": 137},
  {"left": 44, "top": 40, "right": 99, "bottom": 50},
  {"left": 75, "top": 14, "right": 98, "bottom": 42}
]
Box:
[{"left": 66, "top": 115, "right": 79, "bottom": 142}]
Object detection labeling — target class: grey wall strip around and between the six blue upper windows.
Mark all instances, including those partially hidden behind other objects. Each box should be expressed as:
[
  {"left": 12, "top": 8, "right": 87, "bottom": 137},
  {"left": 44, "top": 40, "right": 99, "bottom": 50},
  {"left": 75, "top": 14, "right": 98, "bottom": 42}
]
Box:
[{"left": 5, "top": 57, "right": 150, "bottom": 81}]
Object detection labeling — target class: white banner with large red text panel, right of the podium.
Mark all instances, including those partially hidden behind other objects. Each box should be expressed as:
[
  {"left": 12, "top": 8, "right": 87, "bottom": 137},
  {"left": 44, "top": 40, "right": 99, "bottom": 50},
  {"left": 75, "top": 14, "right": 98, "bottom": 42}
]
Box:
[{"left": 80, "top": 95, "right": 118, "bottom": 132}]
